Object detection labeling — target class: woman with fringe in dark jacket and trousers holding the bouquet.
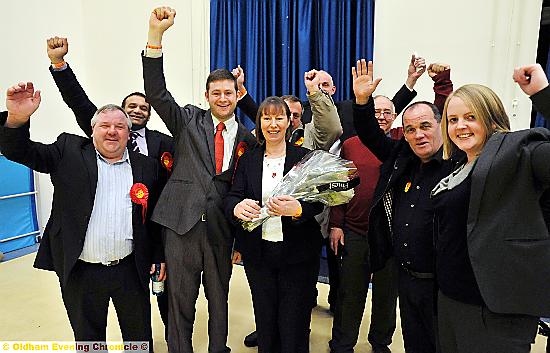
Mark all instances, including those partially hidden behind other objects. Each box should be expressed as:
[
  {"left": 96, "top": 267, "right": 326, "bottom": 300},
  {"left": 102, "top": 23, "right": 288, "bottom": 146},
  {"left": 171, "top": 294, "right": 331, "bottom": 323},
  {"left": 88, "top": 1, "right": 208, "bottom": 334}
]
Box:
[{"left": 225, "top": 97, "right": 323, "bottom": 353}]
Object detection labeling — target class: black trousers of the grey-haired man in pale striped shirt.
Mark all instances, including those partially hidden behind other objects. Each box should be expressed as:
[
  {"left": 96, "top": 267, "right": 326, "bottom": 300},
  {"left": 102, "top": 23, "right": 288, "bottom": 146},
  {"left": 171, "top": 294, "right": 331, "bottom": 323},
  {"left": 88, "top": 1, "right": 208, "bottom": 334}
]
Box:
[{"left": 61, "top": 254, "right": 153, "bottom": 350}]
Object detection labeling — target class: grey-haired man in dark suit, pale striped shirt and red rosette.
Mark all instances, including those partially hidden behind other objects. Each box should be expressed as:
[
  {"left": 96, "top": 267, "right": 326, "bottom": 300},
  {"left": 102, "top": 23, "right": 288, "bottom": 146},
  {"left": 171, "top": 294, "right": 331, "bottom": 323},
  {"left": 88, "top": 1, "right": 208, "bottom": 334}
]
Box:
[{"left": 0, "top": 82, "right": 165, "bottom": 349}]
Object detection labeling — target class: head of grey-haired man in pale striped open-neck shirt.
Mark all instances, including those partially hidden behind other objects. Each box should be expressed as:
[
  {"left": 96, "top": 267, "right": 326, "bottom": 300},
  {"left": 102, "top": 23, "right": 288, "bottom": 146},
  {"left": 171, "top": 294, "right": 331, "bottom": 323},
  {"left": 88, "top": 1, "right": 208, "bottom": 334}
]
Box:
[{"left": 92, "top": 109, "right": 130, "bottom": 162}]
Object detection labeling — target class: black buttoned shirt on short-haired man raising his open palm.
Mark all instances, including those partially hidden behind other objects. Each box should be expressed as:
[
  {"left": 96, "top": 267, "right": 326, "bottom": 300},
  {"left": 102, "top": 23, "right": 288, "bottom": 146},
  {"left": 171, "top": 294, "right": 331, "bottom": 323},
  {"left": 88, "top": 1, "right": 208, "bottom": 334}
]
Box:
[{"left": 392, "top": 149, "right": 452, "bottom": 273}]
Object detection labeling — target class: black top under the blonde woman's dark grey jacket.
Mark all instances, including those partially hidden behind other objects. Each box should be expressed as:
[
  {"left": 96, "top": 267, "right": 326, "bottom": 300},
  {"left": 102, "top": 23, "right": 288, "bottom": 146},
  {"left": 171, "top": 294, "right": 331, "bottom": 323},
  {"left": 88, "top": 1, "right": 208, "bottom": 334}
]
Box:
[{"left": 433, "top": 176, "right": 484, "bottom": 305}]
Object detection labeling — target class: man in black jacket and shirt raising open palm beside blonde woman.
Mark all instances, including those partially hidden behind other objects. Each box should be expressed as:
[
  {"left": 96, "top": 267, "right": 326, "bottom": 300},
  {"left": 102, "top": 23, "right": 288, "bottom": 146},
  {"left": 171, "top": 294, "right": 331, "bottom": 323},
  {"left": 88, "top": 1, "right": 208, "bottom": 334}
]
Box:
[{"left": 352, "top": 60, "right": 455, "bottom": 353}]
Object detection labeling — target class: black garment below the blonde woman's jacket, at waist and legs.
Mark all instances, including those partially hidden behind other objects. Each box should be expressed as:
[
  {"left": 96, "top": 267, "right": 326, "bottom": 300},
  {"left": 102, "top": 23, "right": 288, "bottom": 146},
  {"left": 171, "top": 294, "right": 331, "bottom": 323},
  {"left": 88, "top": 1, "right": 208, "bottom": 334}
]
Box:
[{"left": 437, "top": 291, "right": 538, "bottom": 353}]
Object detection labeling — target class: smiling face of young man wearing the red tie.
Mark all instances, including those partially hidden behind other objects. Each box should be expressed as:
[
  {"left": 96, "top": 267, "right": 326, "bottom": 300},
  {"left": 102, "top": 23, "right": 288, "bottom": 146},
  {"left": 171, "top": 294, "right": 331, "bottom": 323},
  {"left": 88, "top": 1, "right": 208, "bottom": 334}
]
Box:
[{"left": 204, "top": 80, "right": 237, "bottom": 122}]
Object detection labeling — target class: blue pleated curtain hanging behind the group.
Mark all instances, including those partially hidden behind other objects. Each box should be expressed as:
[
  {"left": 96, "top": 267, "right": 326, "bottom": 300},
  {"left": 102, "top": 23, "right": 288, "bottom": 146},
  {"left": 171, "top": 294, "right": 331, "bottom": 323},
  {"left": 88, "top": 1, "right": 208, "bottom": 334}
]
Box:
[{"left": 210, "top": 0, "right": 374, "bottom": 128}]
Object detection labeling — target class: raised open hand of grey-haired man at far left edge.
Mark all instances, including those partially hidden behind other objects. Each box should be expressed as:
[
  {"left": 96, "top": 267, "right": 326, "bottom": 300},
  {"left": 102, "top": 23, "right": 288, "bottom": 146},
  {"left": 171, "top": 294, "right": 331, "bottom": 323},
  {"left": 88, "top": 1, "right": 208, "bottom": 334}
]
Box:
[{"left": 5, "top": 82, "right": 41, "bottom": 128}]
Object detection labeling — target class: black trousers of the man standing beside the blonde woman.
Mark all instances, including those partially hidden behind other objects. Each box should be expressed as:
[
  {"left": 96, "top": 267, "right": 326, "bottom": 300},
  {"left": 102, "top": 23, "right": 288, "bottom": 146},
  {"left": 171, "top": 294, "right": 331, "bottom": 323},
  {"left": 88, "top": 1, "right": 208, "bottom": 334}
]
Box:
[{"left": 398, "top": 267, "right": 438, "bottom": 353}]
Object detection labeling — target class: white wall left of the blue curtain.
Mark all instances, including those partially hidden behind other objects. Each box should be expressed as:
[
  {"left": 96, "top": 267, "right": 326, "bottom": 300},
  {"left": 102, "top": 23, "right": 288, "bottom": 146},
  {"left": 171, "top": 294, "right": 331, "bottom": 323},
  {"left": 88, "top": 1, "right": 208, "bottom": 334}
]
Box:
[{"left": 0, "top": 0, "right": 210, "bottom": 228}]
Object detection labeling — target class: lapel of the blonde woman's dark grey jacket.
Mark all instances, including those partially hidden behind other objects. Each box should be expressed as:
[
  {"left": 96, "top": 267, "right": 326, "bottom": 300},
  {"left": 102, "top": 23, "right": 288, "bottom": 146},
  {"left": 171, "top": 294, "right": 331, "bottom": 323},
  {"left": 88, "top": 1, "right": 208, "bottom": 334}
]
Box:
[{"left": 467, "top": 133, "right": 506, "bottom": 237}]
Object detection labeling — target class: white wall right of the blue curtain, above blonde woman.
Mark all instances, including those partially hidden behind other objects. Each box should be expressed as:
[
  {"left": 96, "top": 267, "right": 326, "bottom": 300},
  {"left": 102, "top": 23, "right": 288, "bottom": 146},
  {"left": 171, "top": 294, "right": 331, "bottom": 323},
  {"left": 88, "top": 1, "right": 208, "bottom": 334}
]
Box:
[{"left": 374, "top": 0, "right": 542, "bottom": 129}]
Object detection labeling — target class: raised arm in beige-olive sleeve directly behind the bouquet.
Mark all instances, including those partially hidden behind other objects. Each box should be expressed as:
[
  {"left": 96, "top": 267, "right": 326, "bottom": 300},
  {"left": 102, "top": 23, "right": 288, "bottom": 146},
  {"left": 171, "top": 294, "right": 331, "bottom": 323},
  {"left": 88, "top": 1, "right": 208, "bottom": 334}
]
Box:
[{"left": 302, "top": 70, "right": 342, "bottom": 151}]
